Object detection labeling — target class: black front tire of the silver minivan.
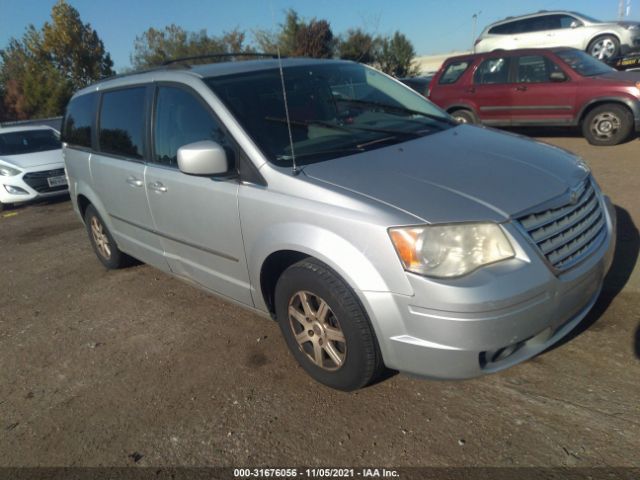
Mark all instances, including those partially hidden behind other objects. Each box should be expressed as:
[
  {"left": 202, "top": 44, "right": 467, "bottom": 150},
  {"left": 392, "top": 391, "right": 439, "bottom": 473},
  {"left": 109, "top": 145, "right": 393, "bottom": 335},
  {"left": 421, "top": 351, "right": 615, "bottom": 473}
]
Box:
[{"left": 275, "top": 258, "right": 384, "bottom": 391}]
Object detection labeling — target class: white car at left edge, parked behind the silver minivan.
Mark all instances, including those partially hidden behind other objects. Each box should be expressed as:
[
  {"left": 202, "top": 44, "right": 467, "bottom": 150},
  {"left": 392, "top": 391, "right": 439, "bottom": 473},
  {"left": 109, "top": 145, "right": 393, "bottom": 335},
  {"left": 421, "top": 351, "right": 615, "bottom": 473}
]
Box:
[{"left": 0, "top": 126, "right": 68, "bottom": 211}]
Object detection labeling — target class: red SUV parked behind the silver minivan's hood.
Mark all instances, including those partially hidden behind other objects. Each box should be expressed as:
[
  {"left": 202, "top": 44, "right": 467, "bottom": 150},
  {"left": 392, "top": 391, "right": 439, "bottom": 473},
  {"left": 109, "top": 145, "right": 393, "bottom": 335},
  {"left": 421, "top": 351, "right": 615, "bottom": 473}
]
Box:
[{"left": 429, "top": 48, "right": 640, "bottom": 145}]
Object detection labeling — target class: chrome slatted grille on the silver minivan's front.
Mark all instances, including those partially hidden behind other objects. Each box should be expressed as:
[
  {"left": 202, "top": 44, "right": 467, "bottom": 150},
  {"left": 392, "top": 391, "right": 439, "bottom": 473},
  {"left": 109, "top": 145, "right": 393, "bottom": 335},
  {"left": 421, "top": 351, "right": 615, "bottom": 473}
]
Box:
[{"left": 519, "top": 180, "right": 606, "bottom": 270}]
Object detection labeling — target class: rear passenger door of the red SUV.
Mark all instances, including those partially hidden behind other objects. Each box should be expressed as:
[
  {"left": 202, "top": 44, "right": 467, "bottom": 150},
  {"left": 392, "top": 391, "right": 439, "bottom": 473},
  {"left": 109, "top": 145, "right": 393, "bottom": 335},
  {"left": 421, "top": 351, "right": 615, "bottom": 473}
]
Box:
[{"left": 468, "top": 56, "right": 512, "bottom": 126}]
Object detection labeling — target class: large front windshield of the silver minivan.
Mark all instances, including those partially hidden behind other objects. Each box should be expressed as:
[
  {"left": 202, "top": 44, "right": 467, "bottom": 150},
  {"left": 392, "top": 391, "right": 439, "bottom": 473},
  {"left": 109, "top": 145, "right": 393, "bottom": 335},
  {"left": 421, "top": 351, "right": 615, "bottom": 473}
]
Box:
[{"left": 206, "top": 62, "right": 457, "bottom": 166}]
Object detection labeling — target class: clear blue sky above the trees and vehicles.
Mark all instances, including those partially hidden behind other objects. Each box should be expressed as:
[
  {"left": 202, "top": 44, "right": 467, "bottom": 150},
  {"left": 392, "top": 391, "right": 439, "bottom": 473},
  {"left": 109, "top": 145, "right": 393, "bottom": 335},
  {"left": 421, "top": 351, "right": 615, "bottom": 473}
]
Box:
[{"left": 0, "top": 0, "right": 640, "bottom": 70}]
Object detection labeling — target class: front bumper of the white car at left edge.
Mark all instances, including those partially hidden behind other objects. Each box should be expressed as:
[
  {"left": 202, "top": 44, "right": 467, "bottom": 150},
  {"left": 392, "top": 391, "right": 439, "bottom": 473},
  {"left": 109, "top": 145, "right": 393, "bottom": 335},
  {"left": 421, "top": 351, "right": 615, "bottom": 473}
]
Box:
[{"left": 0, "top": 164, "right": 69, "bottom": 203}]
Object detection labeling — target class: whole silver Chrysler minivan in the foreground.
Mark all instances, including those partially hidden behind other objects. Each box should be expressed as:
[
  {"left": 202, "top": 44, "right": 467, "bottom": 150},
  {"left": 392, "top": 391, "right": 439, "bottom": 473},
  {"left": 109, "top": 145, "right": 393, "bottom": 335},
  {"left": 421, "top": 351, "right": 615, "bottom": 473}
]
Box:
[{"left": 63, "top": 59, "right": 615, "bottom": 390}]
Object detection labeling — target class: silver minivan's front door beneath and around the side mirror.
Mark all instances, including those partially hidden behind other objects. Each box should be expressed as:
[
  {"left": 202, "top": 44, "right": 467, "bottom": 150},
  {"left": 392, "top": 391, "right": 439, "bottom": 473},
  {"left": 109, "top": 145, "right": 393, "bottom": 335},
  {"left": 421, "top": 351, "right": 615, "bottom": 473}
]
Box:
[{"left": 145, "top": 84, "right": 252, "bottom": 305}]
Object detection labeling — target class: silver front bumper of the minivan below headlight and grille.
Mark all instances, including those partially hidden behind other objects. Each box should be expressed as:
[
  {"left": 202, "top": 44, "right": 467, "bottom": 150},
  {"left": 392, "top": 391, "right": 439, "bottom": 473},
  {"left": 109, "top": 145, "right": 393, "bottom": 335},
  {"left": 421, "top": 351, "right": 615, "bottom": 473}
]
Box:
[{"left": 363, "top": 198, "right": 616, "bottom": 379}]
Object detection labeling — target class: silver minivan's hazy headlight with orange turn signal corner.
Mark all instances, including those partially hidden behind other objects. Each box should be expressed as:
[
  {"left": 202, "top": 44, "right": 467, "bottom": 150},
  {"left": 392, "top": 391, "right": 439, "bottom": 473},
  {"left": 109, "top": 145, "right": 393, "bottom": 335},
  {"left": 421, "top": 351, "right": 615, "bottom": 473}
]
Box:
[{"left": 389, "top": 223, "right": 515, "bottom": 278}]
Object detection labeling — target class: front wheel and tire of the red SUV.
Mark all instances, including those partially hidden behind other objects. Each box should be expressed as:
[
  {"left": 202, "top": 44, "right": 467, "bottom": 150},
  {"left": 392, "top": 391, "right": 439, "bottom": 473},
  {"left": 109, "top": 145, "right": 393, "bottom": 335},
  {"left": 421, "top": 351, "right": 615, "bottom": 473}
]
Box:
[{"left": 582, "top": 103, "right": 634, "bottom": 146}]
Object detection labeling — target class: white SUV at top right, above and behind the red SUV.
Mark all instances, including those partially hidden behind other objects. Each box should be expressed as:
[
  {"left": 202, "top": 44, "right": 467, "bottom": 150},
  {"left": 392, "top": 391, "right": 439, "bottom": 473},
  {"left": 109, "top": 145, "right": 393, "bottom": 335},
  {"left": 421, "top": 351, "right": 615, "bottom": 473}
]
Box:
[{"left": 474, "top": 11, "right": 640, "bottom": 61}]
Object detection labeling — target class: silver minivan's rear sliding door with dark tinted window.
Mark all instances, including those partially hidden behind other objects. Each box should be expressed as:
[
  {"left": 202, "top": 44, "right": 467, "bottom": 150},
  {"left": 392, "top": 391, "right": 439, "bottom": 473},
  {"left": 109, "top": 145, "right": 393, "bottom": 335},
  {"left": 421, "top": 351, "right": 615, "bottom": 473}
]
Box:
[{"left": 90, "top": 86, "right": 168, "bottom": 270}]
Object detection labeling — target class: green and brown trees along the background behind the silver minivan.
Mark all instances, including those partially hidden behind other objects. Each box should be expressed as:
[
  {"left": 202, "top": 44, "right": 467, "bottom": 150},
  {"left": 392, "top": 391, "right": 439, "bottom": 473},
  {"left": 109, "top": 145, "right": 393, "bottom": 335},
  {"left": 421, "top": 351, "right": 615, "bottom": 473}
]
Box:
[{"left": 0, "top": 0, "right": 418, "bottom": 121}]
